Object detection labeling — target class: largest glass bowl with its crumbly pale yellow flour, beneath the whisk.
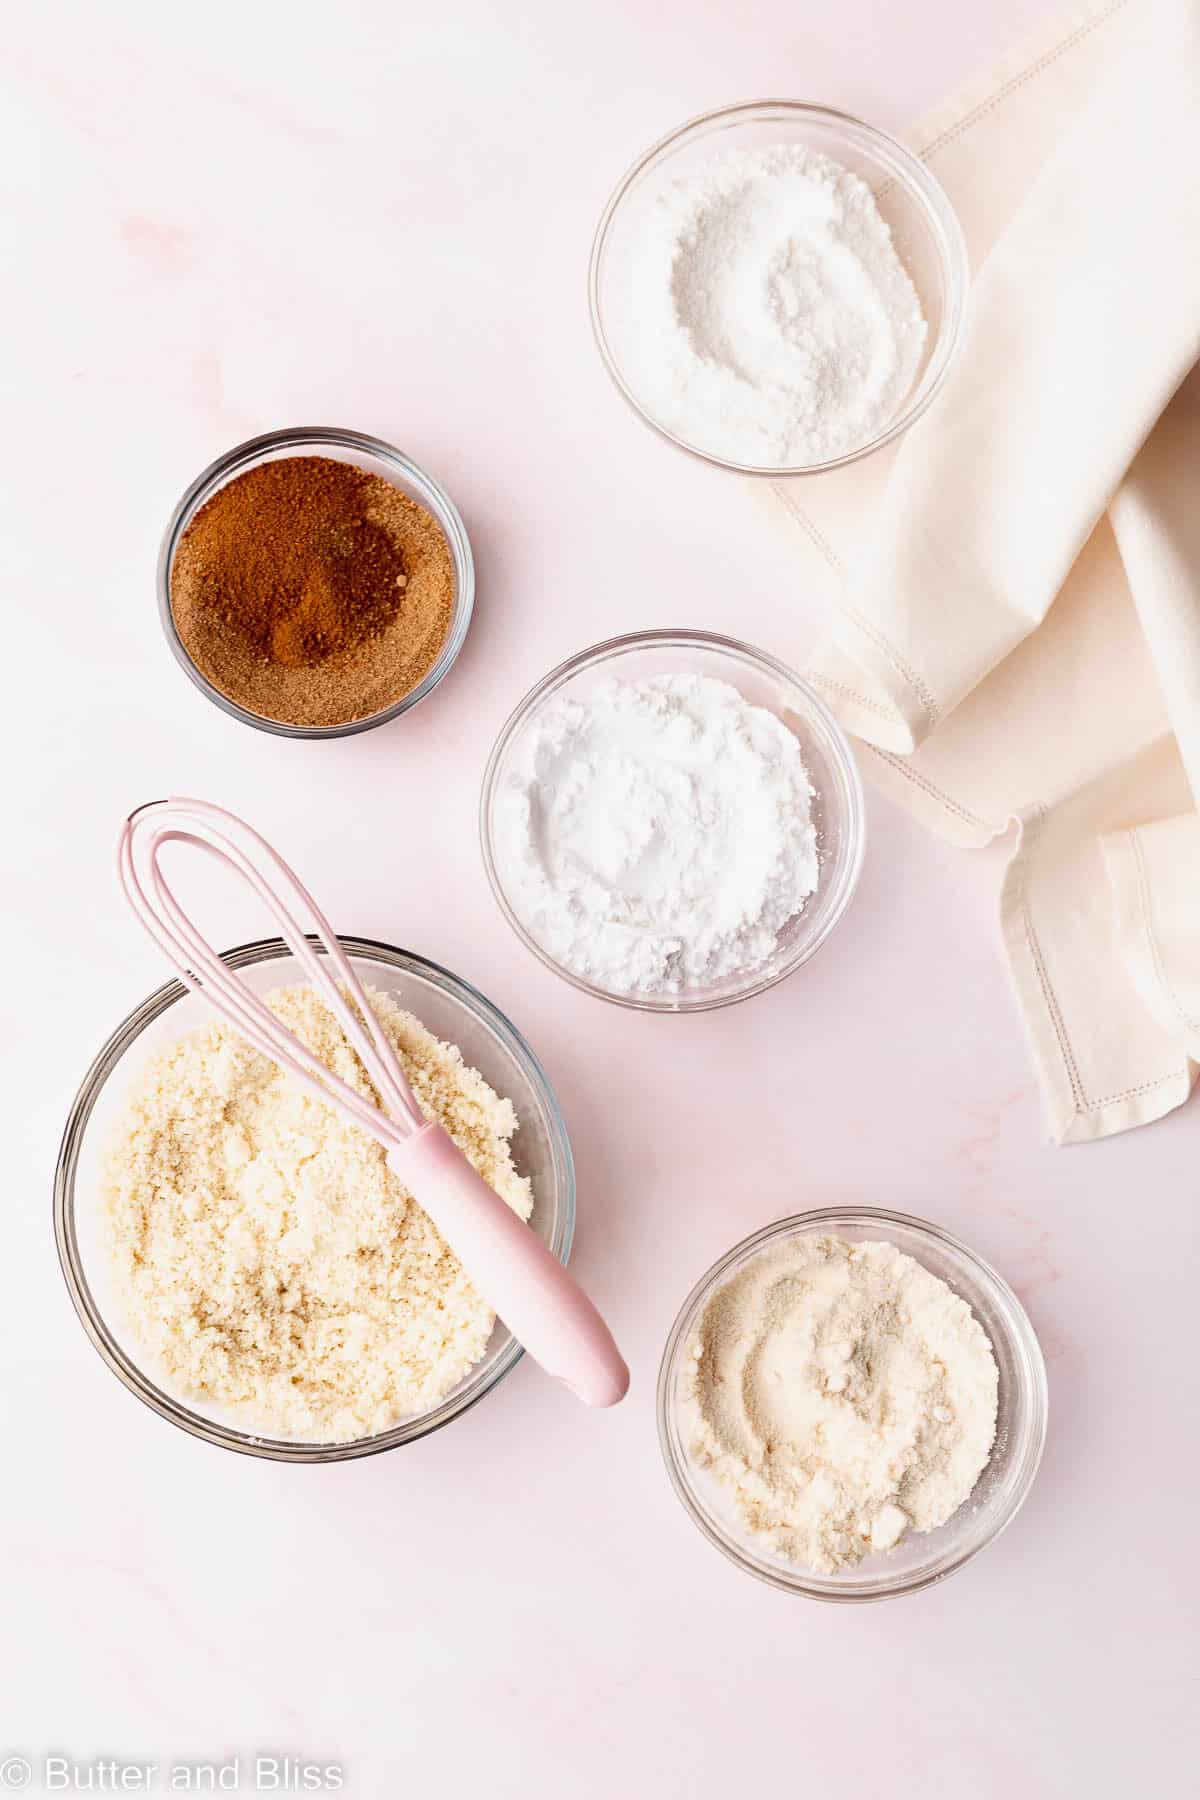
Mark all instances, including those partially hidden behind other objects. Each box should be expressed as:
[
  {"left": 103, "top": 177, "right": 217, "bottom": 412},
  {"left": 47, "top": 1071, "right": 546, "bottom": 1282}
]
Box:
[{"left": 56, "top": 938, "right": 574, "bottom": 1462}]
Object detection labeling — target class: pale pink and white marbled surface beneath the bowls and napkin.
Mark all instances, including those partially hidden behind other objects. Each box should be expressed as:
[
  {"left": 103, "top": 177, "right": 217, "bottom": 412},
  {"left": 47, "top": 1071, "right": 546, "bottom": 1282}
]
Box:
[{"left": 0, "top": 0, "right": 1200, "bottom": 1800}]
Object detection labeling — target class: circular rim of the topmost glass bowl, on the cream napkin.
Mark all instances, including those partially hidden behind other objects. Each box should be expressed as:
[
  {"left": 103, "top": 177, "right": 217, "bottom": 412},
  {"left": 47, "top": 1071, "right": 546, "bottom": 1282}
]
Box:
[{"left": 588, "top": 99, "right": 970, "bottom": 481}]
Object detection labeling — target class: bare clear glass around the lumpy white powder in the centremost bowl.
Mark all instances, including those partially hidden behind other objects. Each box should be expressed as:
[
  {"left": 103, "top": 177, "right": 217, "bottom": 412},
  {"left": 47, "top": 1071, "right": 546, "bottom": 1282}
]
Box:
[{"left": 479, "top": 630, "right": 865, "bottom": 1013}]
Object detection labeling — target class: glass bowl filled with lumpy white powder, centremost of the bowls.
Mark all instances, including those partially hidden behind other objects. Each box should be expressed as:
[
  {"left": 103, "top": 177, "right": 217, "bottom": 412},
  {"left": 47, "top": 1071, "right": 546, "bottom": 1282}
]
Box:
[{"left": 480, "top": 630, "right": 864, "bottom": 1012}]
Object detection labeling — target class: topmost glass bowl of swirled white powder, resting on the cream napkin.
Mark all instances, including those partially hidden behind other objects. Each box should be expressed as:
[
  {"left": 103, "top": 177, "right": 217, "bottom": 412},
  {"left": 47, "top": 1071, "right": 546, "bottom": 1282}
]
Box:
[{"left": 588, "top": 101, "right": 968, "bottom": 475}]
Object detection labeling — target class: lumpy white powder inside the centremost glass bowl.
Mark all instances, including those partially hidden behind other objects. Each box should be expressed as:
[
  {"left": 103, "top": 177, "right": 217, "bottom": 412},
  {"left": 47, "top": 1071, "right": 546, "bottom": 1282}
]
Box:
[{"left": 495, "top": 675, "right": 819, "bottom": 994}]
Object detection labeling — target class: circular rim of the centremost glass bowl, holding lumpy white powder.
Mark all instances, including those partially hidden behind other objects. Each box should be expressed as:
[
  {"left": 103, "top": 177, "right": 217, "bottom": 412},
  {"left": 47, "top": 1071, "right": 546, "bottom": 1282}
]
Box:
[{"left": 479, "top": 626, "right": 867, "bottom": 1015}]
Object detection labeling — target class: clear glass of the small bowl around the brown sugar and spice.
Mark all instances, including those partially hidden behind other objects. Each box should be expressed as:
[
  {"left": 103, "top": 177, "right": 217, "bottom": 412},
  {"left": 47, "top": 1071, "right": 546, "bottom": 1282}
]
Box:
[{"left": 158, "top": 425, "right": 475, "bottom": 738}]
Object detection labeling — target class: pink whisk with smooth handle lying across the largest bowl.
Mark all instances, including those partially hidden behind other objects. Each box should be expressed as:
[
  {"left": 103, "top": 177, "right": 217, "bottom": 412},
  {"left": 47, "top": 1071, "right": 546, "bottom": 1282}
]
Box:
[{"left": 117, "top": 799, "right": 630, "bottom": 1406}]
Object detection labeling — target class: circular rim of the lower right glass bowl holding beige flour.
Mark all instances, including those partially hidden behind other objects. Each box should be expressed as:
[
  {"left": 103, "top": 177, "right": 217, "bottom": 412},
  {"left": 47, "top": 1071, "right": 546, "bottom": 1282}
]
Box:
[{"left": 655, "top": 1206, "right": 1049, "bottom": 1606}]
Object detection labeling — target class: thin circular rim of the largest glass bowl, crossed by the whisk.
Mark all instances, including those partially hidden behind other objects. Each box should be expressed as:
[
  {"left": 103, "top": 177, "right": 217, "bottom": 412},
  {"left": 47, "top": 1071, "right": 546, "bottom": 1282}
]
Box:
[{"left": 52, "top": 932, "right": 576, "bottom": 1463}]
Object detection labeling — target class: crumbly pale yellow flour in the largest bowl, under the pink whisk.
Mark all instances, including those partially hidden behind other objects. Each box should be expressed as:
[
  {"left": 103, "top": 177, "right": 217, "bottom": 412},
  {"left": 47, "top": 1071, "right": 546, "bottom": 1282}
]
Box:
[{"left": 104, "top": 986, "right": 533, "bottom": 1442}]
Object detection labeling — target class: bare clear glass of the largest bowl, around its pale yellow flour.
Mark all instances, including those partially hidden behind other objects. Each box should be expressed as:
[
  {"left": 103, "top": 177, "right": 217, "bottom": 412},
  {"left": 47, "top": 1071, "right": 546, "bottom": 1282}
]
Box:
[{"left": 54, "top": 938, "right": 576, "bottom": 1463}]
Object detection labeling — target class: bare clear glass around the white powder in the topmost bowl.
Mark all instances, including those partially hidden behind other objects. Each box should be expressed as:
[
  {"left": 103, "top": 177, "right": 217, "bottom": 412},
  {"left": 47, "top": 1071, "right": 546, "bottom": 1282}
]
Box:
[{"left": 588, "top": 101, "right": 968, "bottom": 481}]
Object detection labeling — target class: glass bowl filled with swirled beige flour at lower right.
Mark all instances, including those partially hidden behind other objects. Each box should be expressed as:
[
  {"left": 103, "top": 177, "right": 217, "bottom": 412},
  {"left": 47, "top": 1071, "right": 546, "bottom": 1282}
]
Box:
[{"left": 658, "top": 1208, "right": 1047, "bottom": 1600}]
